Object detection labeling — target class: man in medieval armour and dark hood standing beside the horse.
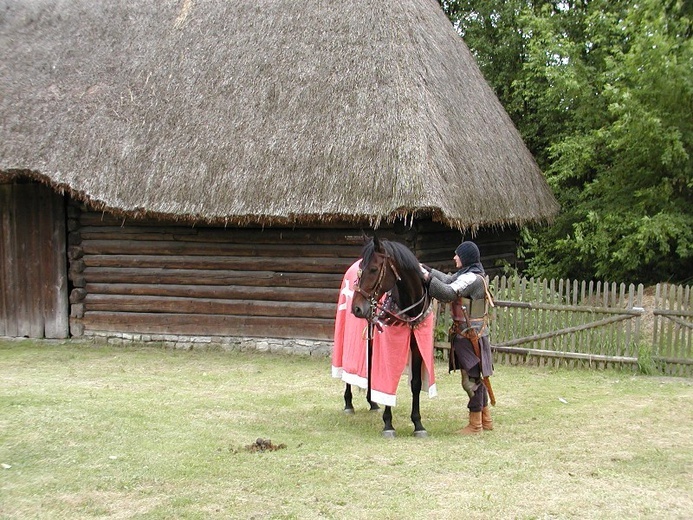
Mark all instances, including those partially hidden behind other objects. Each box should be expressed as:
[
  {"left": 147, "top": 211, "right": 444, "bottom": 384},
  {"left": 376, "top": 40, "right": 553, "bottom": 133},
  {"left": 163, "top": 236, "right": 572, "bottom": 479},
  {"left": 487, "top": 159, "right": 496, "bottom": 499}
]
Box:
[{"left": 424, "top": 241, "right": 495, "bottom": 435}]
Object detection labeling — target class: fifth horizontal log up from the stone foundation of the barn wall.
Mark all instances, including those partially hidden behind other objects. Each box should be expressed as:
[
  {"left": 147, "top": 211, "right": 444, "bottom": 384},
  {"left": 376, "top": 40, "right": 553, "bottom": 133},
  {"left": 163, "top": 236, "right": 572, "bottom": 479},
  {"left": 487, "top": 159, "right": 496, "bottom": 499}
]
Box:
[{"left": 81, "top": 253, "right": 356, "bottom": 275}]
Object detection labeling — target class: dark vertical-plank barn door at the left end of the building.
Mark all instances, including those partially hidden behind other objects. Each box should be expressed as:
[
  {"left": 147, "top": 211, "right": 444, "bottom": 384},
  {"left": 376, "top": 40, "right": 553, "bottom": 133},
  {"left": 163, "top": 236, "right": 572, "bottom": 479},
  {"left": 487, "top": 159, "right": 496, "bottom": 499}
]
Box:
[{"left": 0, "top": 182, "right": 68, "bottom": 338}]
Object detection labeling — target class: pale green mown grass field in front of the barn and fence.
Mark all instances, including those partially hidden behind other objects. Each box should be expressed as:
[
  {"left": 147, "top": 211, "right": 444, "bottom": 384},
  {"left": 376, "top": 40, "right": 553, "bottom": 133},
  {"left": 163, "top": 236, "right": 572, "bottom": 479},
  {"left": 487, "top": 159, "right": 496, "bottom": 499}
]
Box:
[{"left": 0, "top": 339, "right": 693, "bottom": 520}]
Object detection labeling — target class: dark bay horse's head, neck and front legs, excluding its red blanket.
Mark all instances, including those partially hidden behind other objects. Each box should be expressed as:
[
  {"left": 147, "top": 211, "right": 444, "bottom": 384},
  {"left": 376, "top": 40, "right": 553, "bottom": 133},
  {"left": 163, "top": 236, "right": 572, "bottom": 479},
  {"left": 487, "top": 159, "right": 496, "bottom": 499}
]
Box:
[{"left": 351, "top": 237, "right": 432, "bottom": 438}]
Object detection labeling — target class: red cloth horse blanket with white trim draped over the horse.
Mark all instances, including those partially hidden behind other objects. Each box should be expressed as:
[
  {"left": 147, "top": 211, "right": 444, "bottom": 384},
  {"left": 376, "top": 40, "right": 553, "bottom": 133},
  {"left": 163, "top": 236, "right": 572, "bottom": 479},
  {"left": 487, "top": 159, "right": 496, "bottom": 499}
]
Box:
[{"left": 332, "top": 260, "right": 437, "bottom": 406}]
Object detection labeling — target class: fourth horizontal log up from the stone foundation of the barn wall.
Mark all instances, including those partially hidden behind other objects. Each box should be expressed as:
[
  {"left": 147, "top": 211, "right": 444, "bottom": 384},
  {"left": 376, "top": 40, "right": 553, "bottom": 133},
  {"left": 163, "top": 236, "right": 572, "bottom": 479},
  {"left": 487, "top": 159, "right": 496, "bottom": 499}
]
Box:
[{"left": 84, "top": 267, "right": 343, "bottom": 291}]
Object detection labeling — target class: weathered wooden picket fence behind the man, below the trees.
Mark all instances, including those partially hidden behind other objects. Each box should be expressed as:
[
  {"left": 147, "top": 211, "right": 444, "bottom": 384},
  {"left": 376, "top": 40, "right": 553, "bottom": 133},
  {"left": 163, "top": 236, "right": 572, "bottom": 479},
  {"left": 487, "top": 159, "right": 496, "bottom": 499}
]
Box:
[{"left": 436, "top": 276, "right": 693, "bottom": 376}]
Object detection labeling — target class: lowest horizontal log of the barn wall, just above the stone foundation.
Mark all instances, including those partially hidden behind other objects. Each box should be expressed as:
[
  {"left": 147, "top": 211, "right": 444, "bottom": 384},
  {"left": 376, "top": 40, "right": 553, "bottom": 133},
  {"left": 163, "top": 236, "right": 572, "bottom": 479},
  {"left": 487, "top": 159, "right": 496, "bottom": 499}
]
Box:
[{"left": 70, "top": 312, "right": 334, "bottom": 340}]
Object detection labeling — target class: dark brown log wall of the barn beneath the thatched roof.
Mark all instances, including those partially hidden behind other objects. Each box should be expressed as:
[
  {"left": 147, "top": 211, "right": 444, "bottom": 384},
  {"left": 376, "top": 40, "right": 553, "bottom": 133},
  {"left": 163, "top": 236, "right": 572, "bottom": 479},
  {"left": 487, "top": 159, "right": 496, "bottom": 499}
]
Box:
[{"left": 68, "top": 204, "right": 520, "bottom": 341}]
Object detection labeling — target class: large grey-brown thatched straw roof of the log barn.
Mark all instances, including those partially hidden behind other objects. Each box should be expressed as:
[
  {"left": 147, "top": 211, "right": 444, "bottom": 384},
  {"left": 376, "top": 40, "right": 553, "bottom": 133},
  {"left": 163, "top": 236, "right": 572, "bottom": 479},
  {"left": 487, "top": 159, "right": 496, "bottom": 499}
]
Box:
[{"left": 0, "top": 0, "right": 557, "bottom": 232}]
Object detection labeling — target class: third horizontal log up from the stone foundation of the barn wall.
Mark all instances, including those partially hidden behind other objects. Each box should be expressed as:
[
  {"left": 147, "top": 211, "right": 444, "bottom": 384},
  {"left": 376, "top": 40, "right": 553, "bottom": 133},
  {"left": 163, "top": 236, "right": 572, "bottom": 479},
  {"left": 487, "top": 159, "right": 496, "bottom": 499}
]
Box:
[{"left": 85, "top": 283, "right": 339, "bottom": 307}]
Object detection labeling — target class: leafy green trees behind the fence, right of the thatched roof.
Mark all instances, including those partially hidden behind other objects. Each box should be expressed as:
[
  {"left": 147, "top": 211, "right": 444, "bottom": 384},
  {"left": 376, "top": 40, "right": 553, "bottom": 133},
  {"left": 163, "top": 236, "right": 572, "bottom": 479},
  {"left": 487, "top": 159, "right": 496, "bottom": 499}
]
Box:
[{"left": 443, "top": 0, "right": 693, "bottom": 283}]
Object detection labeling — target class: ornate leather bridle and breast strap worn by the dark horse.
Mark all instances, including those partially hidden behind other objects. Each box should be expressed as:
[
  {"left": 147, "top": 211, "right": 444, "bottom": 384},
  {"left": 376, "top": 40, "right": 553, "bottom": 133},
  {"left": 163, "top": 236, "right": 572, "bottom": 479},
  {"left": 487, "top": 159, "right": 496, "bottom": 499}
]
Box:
[{"left": 354, "top": 252, "right": 432, "bottom": 330}]
